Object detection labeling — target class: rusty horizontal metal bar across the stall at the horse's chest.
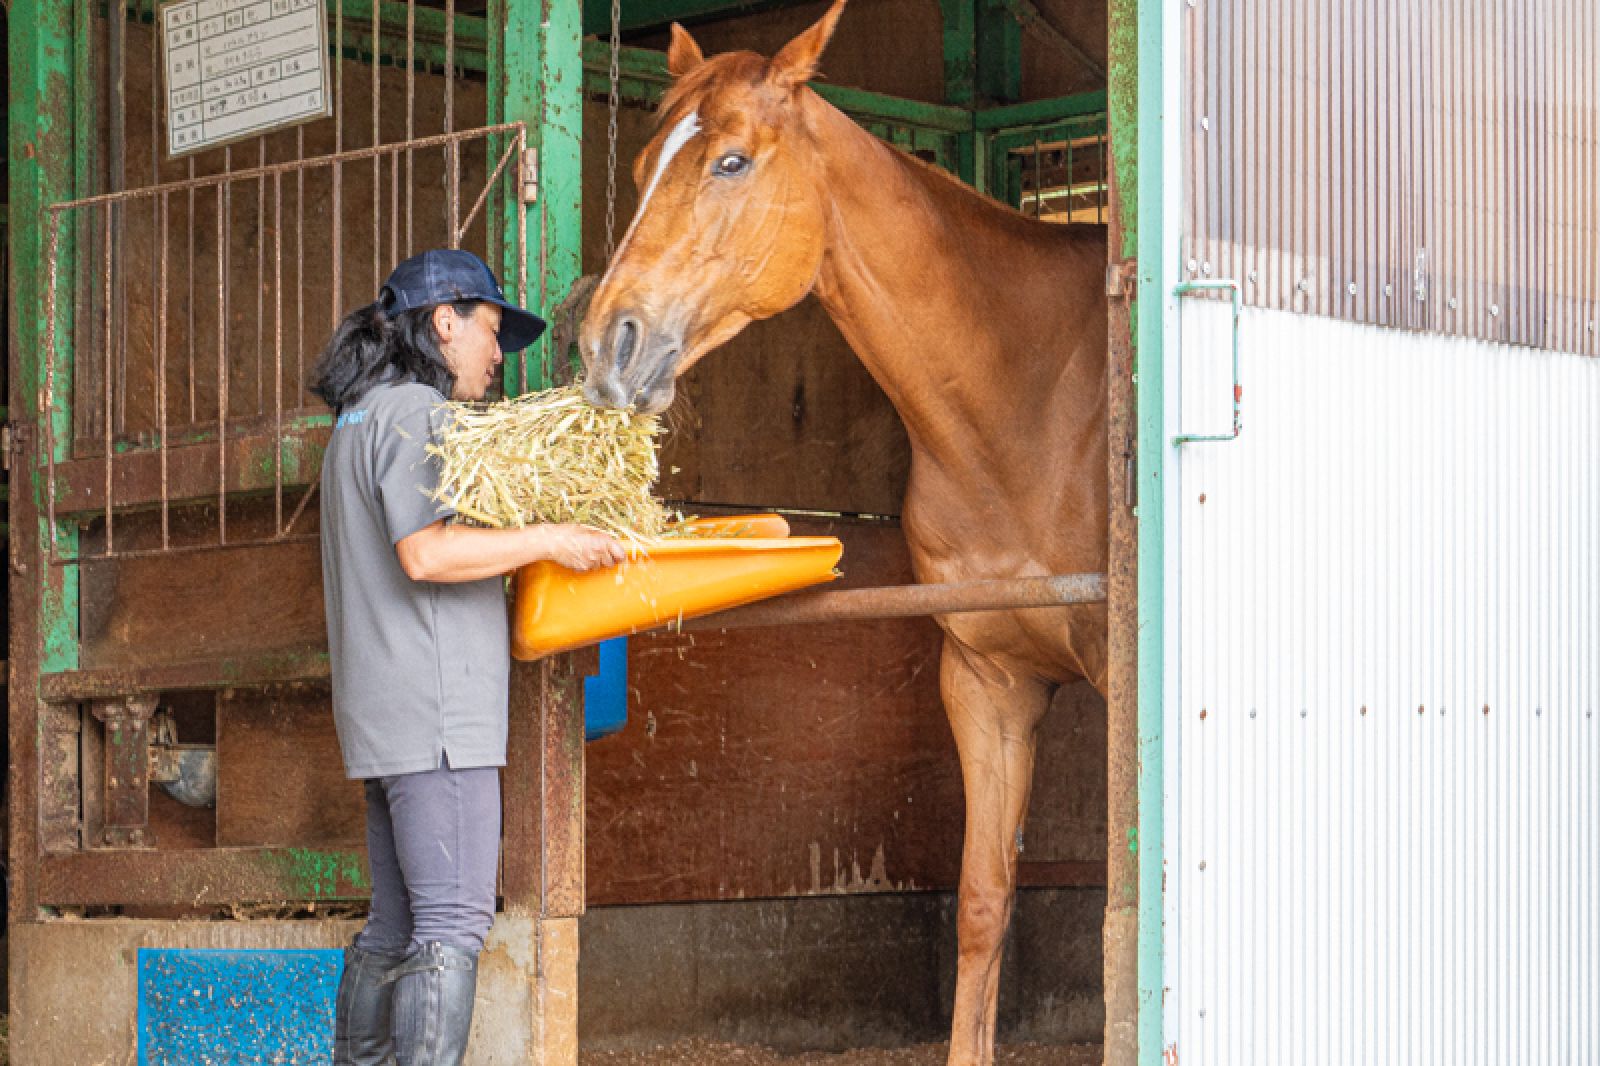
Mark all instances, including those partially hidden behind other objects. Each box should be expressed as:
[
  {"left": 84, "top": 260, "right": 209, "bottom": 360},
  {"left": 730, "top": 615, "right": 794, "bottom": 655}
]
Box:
[{"left": 674, "top": 573, "right": 1106, "bottom": 631}]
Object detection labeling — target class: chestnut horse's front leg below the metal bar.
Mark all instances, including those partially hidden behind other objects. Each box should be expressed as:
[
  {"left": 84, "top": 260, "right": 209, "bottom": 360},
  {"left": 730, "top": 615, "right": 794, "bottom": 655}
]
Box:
[{"left": 939, "top": 635, "right": 1051, "bottom": 1066}]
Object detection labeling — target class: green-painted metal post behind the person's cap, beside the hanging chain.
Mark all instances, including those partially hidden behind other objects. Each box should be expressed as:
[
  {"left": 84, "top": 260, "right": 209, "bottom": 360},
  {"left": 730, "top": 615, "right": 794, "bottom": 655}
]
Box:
[{"left": 490, "top": 0, "right": 584, "bottom": 392}]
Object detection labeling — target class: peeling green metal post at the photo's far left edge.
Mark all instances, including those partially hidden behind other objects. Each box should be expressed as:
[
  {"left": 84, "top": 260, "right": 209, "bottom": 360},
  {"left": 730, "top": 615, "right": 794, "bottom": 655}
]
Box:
[{"left": 8, "top": 0, "right": 81, "bottom": 672}]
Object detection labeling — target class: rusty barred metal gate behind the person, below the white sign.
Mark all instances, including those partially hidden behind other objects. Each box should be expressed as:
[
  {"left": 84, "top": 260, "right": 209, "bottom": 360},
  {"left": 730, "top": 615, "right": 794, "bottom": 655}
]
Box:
[{"left": 38, "top": 123, "right": 528, "bottom": 565}]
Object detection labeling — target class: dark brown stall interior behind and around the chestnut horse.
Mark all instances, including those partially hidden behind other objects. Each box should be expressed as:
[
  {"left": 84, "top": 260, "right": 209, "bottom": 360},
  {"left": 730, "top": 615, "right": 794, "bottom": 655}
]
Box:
[{"left": 579, "top": 0, "right": 1109, "bottom": 1050}]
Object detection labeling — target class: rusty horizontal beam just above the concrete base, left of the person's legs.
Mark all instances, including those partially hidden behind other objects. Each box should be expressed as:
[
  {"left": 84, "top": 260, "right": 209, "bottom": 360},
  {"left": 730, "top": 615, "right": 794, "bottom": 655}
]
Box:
[{"left": 38, "top": 848, "right": 371, "bottom": 908}]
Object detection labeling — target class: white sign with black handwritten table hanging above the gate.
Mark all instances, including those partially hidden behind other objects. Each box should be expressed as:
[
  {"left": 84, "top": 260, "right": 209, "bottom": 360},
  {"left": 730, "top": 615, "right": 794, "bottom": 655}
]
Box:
[{"left": 162, "top": 0, "right": 333, "bottom": 155}]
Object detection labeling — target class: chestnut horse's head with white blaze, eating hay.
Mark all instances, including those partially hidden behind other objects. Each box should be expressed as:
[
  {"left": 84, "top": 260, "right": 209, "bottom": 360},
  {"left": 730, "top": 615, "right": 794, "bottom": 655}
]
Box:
[{"left": 579, "top": 0, "right": 845, "bottom": 413}]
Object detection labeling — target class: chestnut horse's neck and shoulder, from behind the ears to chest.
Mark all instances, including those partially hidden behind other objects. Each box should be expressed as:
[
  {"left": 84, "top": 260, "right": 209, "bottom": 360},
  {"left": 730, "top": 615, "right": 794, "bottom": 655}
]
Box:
[{"left": 806, "top": 93, "right": 1104, "bottom": 482}]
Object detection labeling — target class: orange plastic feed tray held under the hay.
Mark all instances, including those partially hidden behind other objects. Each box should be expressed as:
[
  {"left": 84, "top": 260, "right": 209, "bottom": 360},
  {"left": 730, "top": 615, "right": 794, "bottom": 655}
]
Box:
[{"left": 510, "top": 515, "right": 845, "bottom": 659}]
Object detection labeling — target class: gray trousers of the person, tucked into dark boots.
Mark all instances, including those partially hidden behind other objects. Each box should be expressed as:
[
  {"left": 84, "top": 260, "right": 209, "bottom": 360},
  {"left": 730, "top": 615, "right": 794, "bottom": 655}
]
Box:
[{"left": 355, "top": 762, "right": 501, "bottom": 956}]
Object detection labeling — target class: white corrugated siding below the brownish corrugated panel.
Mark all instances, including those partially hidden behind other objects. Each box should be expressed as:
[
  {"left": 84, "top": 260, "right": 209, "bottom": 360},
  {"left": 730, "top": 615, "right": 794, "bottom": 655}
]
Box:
[{"left": 1168, "top": 298, "right": 1600, "bottom": 1066}]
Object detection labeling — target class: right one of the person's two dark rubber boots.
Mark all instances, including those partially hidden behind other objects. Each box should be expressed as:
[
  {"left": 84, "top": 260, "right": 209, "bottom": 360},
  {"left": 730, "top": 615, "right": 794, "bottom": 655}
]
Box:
[{"left": 387, "top": 941, "right": 478, "bottom": 1066}]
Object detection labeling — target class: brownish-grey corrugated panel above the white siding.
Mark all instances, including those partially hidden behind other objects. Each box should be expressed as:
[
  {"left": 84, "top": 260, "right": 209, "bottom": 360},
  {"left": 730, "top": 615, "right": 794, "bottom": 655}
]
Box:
[{"left": 1184, "top": 0, "right": 1600, "bottom": 355}]
